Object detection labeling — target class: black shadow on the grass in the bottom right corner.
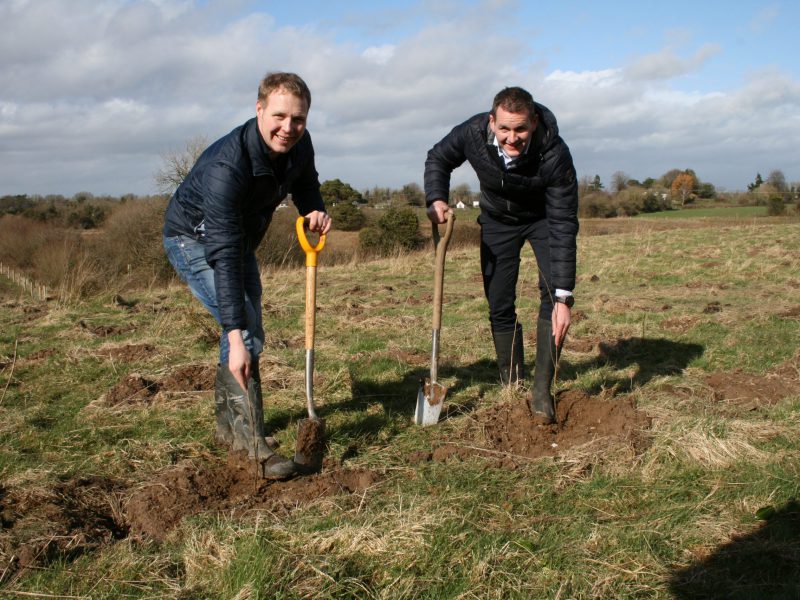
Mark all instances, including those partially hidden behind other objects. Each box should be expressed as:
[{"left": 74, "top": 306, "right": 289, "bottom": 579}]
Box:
[{"left": 669, "top": 499, "right": 800, "bottom": 600}]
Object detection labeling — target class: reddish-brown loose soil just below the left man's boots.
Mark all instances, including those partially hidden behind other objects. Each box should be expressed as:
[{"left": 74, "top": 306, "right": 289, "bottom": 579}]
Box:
[{"left": 125, "top": 457, "right": 378, "bottom": 540}]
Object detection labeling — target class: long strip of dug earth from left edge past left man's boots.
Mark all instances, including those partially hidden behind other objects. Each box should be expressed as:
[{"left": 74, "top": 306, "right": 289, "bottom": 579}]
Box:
[{"left": 0, "top": 457, "right": 380, "bottom": 584}]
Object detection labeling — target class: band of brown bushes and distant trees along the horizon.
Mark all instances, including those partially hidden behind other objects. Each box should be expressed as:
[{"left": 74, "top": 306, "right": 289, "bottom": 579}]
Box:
[{"left": 0, "top": 148, "right": 800, "bottom": 297}]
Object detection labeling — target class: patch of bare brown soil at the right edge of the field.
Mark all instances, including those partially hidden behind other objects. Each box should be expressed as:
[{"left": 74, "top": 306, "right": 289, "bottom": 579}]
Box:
[{"left": 705, "top": 370, "right": 800, "bottom": 410}]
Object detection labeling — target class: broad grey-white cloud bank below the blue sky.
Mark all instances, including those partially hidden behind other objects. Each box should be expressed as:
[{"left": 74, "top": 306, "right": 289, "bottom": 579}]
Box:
[{"left": 0, "top": 0, "right": 800, "bottom": 194}]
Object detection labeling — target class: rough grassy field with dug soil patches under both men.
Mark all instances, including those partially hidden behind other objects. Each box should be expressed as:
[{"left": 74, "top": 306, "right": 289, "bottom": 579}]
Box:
[{"left": 0, "top": 218, "right": 800, "bottom": 600}]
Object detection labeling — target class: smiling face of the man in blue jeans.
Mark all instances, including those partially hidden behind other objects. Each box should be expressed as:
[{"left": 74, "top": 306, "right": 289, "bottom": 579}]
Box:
[{"left": 256, "top": 88, "right": 308, "bottom": 156}]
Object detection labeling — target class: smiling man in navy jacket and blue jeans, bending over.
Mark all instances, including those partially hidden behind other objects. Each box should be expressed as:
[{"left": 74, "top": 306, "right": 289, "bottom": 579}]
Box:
[{"left": 164, "top": 73, "right": 331, "bottom": 478}]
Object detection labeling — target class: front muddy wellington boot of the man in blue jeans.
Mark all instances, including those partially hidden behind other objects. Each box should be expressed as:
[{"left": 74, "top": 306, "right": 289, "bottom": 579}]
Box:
[{"left": 219, "top": 369, "right": 297, "bottom": 479}]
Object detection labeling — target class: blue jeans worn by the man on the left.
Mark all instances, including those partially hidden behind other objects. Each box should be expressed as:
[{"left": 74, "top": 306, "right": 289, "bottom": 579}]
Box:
[{"left": 164, "top": 235, "right": 264, "bottom": 365}]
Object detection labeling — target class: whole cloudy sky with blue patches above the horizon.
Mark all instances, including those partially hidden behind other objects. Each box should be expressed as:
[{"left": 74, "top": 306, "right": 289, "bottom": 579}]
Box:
[{"left": 0, "top": 0, "right": 800, "bottom": 196}]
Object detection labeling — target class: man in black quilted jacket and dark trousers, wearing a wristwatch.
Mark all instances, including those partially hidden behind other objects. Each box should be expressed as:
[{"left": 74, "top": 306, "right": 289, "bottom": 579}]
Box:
[{"left": 425, "top": 87, "right": 578, "bottom": 424}]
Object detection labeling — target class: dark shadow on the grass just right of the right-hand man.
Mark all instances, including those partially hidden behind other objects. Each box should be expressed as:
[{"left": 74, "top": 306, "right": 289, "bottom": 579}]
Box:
[{"left": 559, "top": 337, "right": 705, "bottom": 393}]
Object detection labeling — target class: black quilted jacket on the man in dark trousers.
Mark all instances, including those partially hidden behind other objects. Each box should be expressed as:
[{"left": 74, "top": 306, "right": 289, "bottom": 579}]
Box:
[{"left": 425, "top": 103, "right": 578, "bottom": 290}]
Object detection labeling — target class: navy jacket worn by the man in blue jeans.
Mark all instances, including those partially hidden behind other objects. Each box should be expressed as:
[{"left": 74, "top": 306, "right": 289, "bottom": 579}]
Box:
[{"left": 164, "top": 119, "right": 325, "bottom": 333}]
